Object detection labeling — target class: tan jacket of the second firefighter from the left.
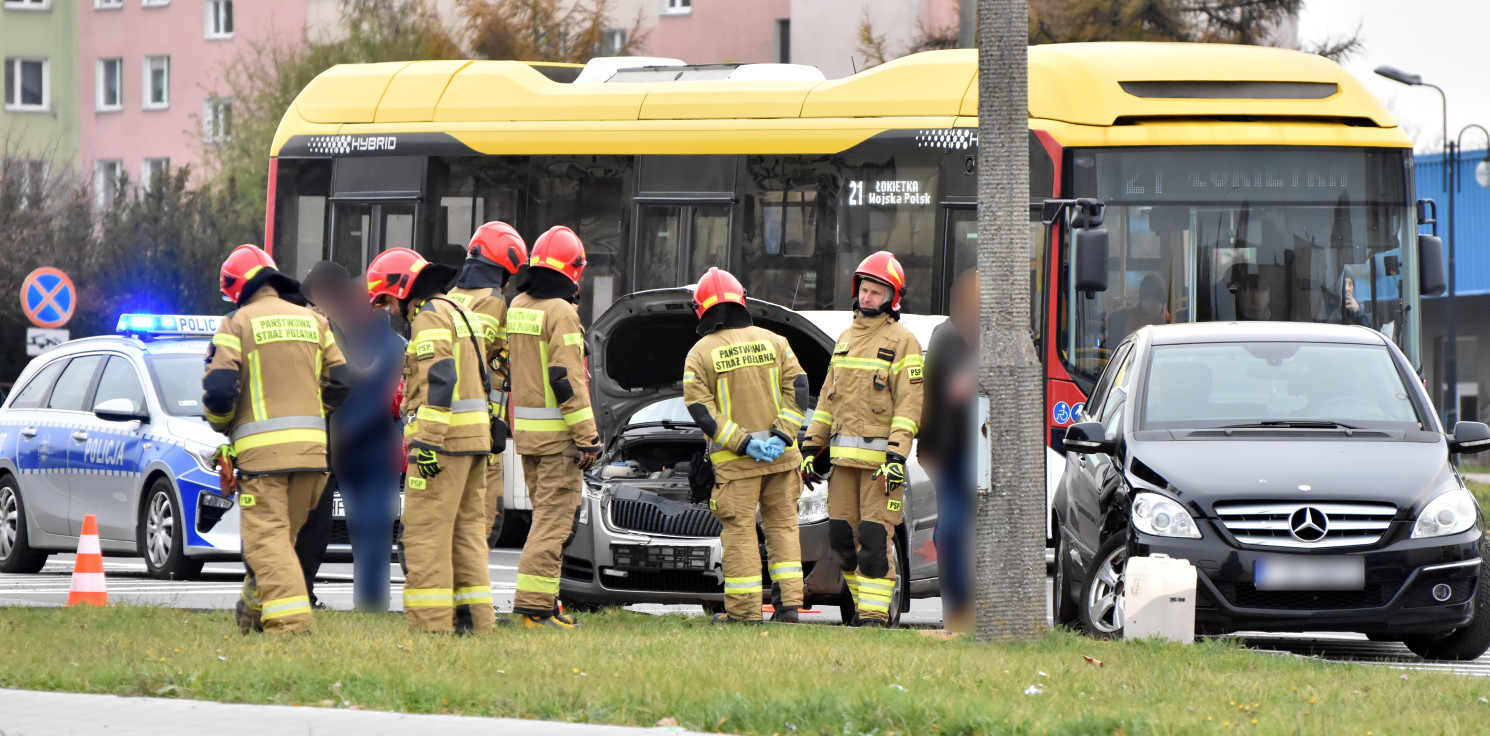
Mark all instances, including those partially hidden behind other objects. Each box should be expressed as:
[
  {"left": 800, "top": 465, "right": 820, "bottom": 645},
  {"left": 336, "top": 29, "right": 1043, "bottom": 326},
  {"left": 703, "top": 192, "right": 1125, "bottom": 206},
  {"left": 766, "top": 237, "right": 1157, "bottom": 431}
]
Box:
[{"left": 402, "top": 296, "right": 492, "bottom": 454}]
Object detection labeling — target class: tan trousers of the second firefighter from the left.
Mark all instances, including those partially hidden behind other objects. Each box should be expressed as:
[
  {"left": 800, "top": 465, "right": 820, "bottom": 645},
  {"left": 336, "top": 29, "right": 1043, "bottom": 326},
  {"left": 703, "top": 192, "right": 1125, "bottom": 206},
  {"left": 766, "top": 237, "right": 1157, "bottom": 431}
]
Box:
[{"left": 404, "top": 453, "right": 496, "bottom": 633}]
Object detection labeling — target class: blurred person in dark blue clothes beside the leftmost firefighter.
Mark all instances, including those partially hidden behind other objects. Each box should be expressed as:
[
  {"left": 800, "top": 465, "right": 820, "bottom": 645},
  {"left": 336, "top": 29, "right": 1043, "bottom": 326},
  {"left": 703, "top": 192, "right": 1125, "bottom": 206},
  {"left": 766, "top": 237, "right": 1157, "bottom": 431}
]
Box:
[{"left": 295, "top": 261, "right": 405, "bottom": 612}]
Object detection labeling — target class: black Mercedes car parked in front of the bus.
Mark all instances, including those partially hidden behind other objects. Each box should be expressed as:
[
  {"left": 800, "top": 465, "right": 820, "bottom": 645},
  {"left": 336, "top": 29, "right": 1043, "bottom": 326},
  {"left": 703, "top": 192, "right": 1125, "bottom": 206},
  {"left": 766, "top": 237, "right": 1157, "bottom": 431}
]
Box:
[{"left": 1053, "top": 322, "right": 1490, "bottom": 660}]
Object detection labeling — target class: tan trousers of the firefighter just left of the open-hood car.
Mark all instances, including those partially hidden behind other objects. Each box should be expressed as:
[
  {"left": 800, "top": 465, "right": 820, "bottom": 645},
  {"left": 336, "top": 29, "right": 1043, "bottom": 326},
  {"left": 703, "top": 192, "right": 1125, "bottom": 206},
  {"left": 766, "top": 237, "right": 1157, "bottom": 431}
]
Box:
[{"left": 513, "top": 454, "right": 584, "bottom": 615}]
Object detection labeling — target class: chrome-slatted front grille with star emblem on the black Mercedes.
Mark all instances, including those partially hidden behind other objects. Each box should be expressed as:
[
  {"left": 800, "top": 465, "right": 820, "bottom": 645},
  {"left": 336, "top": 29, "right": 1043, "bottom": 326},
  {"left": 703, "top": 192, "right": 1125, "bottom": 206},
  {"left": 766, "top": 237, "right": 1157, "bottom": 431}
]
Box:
[{"left": 1216, "top": 502, "right": 1398, "bottom": 550}]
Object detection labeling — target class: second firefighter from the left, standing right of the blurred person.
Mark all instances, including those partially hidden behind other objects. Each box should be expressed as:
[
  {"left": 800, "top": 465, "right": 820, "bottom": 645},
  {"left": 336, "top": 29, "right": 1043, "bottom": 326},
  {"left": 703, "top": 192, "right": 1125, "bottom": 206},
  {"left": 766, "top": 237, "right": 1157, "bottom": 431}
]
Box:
[{"left": 367, "top": 247, "right": 495, "bottom": 633}]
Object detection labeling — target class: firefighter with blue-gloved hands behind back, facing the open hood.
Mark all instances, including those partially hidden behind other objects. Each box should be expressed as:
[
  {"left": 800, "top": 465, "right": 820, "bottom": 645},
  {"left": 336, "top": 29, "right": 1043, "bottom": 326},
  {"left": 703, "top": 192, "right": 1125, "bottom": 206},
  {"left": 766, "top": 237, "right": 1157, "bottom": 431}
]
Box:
[{"left": 682, "top": 268, "right": 808, "bottom": 624}]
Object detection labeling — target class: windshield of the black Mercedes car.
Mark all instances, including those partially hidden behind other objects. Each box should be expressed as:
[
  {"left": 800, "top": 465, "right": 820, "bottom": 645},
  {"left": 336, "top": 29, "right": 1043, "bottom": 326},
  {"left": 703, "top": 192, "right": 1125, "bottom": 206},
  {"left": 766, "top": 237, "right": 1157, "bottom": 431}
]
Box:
[{"left": 1141, "top": 343, "right": 1421, "bottom": 429}]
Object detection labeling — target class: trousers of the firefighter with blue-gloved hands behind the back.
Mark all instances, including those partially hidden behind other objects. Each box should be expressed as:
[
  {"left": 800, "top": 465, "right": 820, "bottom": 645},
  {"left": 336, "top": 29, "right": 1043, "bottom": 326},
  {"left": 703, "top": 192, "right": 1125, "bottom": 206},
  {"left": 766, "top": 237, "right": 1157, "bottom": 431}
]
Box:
[{"left": 709, "top": 469, "right": 802, "bottom": 621}]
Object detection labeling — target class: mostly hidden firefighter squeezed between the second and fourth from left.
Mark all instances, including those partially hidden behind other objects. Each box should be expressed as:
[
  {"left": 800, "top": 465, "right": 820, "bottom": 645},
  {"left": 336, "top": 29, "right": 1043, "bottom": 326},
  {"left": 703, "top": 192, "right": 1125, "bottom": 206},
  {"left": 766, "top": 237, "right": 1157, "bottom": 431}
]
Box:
[{"left": 450, "top": 222, "right": 527, "bottom": 542}]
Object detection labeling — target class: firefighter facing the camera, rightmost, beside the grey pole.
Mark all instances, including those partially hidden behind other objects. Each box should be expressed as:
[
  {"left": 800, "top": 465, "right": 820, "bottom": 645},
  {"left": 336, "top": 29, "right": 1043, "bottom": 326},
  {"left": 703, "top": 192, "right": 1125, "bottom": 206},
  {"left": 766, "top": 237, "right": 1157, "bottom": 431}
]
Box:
[{"left": 802, "top": 250, "right": 922, "bottom": 626}]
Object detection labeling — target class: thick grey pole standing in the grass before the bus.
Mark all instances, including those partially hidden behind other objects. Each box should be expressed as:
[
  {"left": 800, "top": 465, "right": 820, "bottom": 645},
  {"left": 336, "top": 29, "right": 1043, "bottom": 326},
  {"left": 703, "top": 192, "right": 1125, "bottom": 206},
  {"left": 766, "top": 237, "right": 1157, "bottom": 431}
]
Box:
[{"left": 973, "top": 0, "right": 1046, "bottom": 641}]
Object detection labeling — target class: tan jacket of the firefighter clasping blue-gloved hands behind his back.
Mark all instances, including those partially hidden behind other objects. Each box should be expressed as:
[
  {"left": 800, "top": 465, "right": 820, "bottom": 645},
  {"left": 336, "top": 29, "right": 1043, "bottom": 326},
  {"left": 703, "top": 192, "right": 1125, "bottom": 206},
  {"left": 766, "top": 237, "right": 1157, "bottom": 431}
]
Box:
[{"left": 682, "top": 325, "right": 808, "bottom": 480}]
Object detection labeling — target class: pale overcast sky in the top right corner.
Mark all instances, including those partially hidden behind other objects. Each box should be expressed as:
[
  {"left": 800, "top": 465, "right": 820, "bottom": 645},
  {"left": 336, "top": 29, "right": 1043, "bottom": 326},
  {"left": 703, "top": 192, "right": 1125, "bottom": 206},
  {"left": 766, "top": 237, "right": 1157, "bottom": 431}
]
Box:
[{"left": 1299, "top": 0, "right": 1490, "bottom": 150}]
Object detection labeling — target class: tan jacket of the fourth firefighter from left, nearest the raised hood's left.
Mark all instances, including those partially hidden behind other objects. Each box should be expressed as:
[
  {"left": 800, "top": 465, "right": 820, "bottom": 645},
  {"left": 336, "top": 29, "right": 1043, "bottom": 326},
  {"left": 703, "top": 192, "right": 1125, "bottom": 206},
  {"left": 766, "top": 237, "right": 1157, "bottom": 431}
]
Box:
[{"left": 507, "top": 294, "right": 600, "bottom": 454}]
